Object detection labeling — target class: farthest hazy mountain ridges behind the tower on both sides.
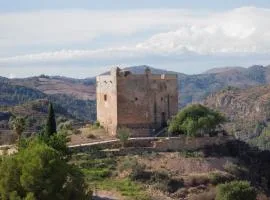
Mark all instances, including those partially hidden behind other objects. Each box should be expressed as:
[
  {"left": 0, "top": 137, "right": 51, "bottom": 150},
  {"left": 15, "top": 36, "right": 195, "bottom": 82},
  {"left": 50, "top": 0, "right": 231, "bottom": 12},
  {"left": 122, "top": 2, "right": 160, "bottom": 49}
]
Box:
[{"left": 0, "top": 65, "right": 270, "bottom": 107}]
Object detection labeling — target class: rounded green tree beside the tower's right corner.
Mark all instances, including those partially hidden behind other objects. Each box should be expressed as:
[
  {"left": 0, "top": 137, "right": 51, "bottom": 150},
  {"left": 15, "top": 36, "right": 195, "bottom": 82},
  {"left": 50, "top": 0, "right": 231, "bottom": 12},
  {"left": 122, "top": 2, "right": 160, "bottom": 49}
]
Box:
[{"left": 168, "top": 104, "right": 225, "bottom": 136}]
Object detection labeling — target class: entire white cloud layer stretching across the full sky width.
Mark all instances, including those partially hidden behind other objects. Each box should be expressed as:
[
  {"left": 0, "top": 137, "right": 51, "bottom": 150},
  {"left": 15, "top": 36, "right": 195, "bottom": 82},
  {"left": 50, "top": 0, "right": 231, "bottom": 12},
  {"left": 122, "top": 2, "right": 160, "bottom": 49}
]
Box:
[{"left": 0, "top": 7, "right": 270, "bottom": 64}]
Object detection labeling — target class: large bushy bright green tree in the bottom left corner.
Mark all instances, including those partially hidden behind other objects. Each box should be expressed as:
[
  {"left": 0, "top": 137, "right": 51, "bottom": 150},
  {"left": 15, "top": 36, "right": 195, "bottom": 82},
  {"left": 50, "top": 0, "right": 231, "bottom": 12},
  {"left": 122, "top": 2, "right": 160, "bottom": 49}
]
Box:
[{"left": 0, "top": 139, "right": 91, "bottom": 200}]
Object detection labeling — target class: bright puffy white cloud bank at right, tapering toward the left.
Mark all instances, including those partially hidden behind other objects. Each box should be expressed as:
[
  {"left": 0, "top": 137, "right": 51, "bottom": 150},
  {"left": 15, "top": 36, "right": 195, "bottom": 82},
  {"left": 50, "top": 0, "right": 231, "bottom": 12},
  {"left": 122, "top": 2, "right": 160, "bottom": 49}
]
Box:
[{"left": 137, "top": 7, "right": 270, "bottom": 54}]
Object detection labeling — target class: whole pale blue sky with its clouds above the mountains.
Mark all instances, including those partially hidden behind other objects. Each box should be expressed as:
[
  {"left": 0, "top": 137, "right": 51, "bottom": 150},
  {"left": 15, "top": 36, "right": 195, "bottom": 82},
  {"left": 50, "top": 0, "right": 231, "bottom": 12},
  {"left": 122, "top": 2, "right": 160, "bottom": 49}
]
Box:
[{"left": 0, "top": 0, "right": 270, "bottom": 78}]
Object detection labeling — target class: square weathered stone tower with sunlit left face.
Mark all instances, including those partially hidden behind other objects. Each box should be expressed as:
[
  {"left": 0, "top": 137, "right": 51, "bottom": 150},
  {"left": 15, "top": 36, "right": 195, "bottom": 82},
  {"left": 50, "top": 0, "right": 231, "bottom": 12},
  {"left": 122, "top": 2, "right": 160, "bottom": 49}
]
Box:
[{"left": 96, "top": 68, "right": 178, "bottom": 137}]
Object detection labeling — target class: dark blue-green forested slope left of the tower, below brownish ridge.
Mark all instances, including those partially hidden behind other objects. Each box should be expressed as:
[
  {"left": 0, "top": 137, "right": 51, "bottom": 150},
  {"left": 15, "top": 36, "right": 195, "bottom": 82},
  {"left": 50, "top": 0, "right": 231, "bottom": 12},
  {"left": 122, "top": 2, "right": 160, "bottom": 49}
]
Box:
[{"left": 0, "top": 82, "right": 96, "bottom": 121}]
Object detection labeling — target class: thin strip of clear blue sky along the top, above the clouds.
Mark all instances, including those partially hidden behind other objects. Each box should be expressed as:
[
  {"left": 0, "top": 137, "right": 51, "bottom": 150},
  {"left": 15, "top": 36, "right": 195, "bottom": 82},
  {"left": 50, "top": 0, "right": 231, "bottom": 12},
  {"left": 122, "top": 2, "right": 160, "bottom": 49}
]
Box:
[{"left": 0, "top": 0, "right": 270, "bottom": 12}]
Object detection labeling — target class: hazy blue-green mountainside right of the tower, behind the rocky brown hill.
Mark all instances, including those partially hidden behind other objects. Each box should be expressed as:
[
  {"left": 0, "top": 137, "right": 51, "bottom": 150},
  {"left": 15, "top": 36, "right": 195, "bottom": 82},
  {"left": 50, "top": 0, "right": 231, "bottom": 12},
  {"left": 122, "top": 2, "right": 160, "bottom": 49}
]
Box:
[{"left": 179, "top": 66, "right": 270, "bottom": 105}]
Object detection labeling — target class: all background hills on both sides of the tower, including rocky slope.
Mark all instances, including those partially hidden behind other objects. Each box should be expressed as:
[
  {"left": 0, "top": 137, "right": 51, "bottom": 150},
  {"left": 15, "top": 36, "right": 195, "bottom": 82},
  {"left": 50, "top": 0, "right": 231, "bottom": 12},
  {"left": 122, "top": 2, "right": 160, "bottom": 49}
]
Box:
[{"left": 0, "top": 65, "right": 270, "bottom": 142}]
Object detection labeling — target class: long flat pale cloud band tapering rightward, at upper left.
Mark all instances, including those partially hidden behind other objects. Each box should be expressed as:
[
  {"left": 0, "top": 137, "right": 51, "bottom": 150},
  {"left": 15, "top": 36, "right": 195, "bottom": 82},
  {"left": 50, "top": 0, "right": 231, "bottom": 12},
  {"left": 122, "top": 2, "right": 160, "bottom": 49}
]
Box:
[{"left": 0, "top": 10, "right": 202, "bottom": 47}]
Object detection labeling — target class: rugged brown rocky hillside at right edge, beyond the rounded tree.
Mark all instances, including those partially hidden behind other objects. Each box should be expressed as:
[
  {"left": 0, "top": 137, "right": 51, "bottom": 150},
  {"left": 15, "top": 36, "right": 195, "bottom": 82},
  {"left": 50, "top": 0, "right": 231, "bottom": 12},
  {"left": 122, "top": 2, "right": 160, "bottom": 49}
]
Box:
[{"left": 204, "top": 85, "right": 270, "bottom": 137}]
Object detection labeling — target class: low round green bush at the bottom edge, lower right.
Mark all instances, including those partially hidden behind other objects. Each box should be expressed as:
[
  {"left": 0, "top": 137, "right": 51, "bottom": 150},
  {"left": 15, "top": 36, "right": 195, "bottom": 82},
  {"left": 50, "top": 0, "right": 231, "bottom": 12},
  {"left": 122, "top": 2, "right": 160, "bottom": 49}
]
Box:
[{"left": 216, "top": 181, "right": 257, "bottom": 200}]
